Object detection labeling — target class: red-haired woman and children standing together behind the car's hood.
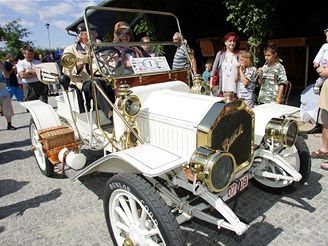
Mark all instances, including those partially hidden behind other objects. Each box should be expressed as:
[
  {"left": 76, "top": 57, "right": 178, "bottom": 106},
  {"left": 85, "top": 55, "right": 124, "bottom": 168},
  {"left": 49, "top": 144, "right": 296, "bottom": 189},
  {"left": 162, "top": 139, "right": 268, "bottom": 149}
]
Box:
[{"left": 203, "top": 32, "right": 288, "bottom": 107}]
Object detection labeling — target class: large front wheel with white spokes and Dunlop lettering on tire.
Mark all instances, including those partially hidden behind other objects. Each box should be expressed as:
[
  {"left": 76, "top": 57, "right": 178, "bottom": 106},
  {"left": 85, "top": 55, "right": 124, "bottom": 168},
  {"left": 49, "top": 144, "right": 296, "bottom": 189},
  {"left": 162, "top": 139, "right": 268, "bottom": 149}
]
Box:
[{"left": 103, "top": 173, "right": 186, "bottom": 246}]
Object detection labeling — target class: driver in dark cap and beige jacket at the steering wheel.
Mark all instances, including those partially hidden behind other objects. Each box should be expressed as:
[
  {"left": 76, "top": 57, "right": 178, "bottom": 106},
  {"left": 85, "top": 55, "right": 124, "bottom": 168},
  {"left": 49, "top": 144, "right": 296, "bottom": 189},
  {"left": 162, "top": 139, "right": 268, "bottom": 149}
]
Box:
[{"left": 63, "top": 23, "right": 115, "bottom": 118}]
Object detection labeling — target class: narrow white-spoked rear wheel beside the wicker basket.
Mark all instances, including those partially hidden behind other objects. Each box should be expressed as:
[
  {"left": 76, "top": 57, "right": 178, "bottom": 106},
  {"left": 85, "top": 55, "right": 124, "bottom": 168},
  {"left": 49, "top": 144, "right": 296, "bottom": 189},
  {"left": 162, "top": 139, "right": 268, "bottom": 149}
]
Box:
[{"left": 29, "top": 120, "right": 54, "bottom": 177}]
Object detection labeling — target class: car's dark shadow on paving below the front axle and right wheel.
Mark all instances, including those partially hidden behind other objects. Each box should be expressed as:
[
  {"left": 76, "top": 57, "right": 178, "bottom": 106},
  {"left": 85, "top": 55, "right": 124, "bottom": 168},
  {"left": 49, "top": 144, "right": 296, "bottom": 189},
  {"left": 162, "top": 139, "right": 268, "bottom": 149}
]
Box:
[{"left": 182, "top": 168, "right": 322, "bottom": 246}]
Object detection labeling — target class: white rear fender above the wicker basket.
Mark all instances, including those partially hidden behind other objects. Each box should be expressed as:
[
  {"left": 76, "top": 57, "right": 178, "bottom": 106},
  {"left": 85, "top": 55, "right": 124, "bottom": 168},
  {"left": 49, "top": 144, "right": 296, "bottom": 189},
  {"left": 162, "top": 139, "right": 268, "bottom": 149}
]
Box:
[{"left": 20, "top": 100, "right": 61, "bottom": 130}]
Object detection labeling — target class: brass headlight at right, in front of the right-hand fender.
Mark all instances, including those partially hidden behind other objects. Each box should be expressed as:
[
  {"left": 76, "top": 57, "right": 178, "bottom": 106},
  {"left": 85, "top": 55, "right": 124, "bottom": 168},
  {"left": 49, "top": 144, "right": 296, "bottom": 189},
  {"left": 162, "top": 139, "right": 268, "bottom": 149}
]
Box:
[{"left": 265, "top": 118, "right": 298, "bottom": 147}]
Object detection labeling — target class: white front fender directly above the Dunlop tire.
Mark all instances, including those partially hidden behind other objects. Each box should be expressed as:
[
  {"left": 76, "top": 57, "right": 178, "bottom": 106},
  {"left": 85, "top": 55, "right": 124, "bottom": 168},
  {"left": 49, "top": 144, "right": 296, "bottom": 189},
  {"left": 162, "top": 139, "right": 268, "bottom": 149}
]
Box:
[{"left": 72, "top": 144, "right": 187, "bottom": 181}]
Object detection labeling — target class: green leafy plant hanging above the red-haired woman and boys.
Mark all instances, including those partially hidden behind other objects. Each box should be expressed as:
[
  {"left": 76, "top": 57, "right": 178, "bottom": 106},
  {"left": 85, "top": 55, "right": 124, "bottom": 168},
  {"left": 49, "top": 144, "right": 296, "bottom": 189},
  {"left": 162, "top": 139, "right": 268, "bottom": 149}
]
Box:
[{"left": 223, "top": 0, "right": 274, "bottom": 65}]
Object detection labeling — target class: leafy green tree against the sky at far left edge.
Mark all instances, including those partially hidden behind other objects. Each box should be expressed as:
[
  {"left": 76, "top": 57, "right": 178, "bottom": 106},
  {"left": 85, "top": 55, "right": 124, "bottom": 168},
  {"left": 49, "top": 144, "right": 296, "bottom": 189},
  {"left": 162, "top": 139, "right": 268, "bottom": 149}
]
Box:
[{"left": 0, "top": 19, "right": 32, "bottom": 54}]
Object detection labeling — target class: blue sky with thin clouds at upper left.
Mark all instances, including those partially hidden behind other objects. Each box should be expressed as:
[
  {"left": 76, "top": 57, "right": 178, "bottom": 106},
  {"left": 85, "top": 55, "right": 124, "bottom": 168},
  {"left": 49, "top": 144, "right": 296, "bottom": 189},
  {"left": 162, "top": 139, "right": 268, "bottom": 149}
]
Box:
[{"left": 0, "top": 0, "right": 102, "bottom": 49}]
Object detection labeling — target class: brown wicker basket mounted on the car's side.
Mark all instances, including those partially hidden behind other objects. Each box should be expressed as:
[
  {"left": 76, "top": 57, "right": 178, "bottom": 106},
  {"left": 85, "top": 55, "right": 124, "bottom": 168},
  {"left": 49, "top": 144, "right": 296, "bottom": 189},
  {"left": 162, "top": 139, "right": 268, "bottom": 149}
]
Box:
[{"left": 38, "top": 125, "right": 76, "bottom": 150}]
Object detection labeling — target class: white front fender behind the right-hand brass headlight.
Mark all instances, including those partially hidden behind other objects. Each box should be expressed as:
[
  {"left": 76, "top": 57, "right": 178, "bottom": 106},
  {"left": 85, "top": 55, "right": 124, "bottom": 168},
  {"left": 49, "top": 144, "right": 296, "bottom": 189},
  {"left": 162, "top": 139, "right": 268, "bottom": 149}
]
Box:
[{"left": 253, "top": 103, "right": 300, "bottom": 145}]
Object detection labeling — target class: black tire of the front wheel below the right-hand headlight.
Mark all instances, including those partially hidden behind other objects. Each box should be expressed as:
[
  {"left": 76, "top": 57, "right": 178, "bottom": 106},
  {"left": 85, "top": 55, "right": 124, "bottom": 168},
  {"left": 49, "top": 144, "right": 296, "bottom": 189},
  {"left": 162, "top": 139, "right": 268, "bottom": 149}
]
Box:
[{"left": 252, "top": 136, "right": 311, "bottom": 194}]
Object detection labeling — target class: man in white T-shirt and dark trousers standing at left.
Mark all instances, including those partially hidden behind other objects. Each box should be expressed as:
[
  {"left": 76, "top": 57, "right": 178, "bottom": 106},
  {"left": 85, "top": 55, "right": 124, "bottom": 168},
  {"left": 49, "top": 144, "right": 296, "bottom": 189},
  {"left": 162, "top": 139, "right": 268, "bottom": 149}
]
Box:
[{"left": 16, "top": 45, "right": 48, "bottom": 103}]
